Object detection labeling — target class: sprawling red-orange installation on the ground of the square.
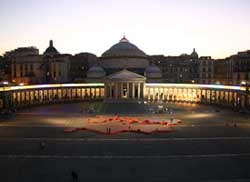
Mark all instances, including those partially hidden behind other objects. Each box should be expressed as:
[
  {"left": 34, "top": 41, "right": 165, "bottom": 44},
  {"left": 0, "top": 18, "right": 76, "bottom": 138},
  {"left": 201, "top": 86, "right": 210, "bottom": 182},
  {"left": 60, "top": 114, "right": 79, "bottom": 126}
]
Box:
[{"left": 64, "top": 115, "right": 181, "bottom": 135}]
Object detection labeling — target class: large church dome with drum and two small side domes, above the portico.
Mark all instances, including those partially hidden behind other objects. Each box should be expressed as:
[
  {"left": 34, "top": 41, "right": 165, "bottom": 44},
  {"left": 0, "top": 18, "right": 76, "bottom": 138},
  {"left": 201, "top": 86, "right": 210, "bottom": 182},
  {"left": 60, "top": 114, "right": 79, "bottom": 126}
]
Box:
[{"left": 88, "top": 36, "right": 162, "bottom": 81}]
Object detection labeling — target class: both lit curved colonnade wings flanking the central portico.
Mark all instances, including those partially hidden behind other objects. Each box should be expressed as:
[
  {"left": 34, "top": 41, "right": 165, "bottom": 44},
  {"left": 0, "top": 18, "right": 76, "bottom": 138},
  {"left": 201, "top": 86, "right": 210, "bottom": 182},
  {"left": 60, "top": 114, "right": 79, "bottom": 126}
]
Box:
[{"left": 0, "top": 83, "right": 250, "bottom": 109}]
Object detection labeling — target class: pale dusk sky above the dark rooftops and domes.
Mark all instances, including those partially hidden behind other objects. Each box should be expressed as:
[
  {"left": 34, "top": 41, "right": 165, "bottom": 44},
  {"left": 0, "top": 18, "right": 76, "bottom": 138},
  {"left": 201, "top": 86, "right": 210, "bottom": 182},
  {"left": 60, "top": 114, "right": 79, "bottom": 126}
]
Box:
[{"left": 0, "top": 0, "right": 250, "bottom": 58}]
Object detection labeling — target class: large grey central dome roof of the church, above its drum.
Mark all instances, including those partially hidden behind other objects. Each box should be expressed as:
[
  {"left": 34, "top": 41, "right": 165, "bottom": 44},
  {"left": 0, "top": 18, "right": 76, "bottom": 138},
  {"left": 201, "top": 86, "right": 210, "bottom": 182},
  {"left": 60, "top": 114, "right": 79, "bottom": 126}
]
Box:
[{"left": 102, "top": 36, "right": 147, "bottom": 58}]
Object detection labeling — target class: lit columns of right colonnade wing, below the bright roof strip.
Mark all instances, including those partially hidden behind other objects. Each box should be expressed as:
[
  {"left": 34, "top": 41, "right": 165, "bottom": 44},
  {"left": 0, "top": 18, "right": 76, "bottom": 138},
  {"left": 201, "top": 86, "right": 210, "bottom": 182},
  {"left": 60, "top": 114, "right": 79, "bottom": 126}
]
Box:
[{"left": 145, "top": 86, "right": 250, "bottom": 108}]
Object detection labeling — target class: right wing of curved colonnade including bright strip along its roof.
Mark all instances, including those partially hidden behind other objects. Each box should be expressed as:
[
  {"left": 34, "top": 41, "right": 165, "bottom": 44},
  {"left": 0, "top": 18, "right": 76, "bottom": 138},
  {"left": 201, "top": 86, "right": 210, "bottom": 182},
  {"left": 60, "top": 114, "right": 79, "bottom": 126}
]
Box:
[{"left": 144, "top": 83, "right": 247, "bottom": 108}]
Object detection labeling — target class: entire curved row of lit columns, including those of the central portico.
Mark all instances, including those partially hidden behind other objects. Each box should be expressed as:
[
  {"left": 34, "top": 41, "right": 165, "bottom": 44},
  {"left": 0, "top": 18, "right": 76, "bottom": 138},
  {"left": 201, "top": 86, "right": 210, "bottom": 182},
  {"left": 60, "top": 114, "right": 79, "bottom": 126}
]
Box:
[{"left": 0, "top": 81, "right": 250, "bottom": 110}]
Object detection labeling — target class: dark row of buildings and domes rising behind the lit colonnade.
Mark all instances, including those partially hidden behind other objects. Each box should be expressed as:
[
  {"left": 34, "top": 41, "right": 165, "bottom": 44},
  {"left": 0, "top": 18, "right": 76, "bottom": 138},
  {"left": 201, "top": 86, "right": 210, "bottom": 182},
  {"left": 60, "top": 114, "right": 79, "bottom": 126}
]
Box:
[{"left": 0, "top": 37, "right": 250, "bottom": 85}]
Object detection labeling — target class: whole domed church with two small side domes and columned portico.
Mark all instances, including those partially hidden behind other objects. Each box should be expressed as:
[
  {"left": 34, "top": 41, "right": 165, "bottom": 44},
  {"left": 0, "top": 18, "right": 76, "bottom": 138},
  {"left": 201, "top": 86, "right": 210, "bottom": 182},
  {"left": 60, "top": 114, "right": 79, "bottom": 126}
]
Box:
[{"left": 87, "top": 36, "right": 162, "bottom": 102}]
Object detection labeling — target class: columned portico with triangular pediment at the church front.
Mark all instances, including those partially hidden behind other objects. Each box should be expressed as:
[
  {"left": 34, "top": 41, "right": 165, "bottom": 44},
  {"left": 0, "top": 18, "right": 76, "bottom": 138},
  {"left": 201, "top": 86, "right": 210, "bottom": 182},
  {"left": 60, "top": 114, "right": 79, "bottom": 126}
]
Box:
[{"left": 104, "top": 69, "right": 146, "bottom": 102}]
